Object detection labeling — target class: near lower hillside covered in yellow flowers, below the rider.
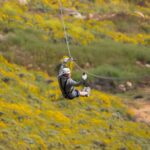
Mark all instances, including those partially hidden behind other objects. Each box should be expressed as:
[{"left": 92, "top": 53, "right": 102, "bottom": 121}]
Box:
[{"left": 0, "top": 56, "right": 150, "bottom": 150}]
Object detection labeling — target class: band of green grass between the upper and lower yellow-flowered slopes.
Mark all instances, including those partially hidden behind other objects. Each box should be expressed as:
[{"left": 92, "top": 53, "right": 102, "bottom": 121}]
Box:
[{"left": 0, "top": 29, "right": 150, "bottom": 83}]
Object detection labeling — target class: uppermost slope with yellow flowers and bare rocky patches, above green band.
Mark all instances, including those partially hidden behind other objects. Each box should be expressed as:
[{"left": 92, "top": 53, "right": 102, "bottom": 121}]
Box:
[{"left": 0, "top": 0, "right": 150, "bottom": 45}]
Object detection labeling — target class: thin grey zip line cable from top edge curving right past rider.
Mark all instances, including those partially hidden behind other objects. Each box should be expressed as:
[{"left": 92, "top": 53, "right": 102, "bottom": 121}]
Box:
[{"left": 58, "top": 0, "right": 145, "bottom": 81}]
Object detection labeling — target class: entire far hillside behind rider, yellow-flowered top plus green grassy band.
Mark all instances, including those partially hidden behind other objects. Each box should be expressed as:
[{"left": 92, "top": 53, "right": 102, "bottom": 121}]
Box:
[{"left": 0, "top": 0, "right": 150, "bottom": 82}]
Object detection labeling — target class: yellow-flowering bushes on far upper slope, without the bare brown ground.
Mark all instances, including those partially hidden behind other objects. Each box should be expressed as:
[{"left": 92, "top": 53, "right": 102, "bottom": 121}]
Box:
[{"left": 0, "top": 0, "right": 150, "bottom": 45}]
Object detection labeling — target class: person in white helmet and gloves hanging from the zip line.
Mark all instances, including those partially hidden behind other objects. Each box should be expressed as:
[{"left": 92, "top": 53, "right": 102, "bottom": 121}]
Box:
[{"left": 58, "top": 58, "right": 90, "bottom": 99}]
